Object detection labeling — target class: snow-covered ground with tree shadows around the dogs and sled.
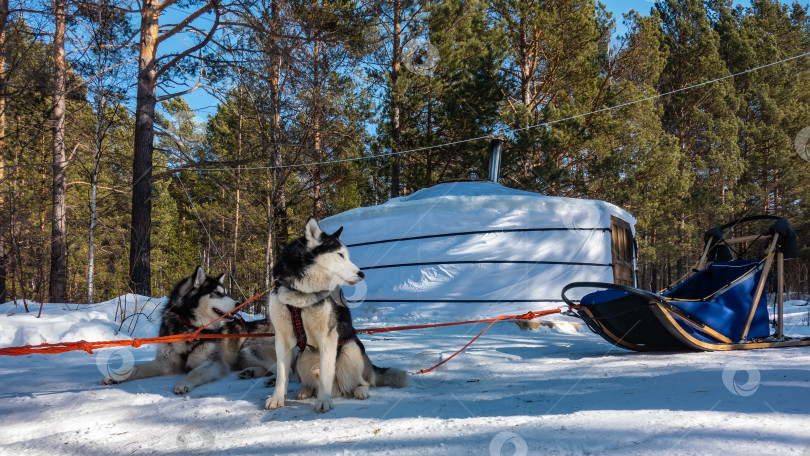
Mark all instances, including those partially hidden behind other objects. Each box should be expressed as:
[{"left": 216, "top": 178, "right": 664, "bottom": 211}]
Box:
[{"left": 0, "top": 296, "right": 810, "bottom": 456}]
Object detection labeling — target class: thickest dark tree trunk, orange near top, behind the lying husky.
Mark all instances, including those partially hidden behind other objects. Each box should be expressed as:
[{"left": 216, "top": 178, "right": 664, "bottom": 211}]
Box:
[{"left": 129, "top": 0, "right": 160, "bottom": 296}]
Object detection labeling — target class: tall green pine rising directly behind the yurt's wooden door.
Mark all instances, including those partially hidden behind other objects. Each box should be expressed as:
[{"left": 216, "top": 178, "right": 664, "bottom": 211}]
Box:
[{"left": 612, "top": 12, "right": 691, "bottom": 291}]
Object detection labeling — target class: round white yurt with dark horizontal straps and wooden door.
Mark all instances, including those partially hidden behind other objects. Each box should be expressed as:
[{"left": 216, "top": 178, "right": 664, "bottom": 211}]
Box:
[{"left": 321, "top": 181, "right": 635, "bottom": 321}]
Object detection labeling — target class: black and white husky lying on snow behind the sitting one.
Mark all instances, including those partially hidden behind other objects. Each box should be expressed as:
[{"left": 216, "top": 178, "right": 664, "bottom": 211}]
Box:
[{"left": 101, "top": 266, "right": 276, "bottom": 394}]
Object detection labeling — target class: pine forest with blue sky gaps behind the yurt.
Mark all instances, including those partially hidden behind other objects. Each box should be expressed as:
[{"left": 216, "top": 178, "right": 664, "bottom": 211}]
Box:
[{"left": 0, "top": 0, "right": 810, "bottom": 310}]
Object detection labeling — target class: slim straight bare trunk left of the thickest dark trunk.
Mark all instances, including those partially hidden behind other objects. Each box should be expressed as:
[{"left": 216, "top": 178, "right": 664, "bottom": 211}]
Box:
[{"left": 50, "top": 0, "right": 67, "bottom": 302}]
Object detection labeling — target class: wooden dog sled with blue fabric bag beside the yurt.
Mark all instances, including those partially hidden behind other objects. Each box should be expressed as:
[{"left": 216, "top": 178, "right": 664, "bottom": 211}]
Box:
[{"left": 562, "top": 215, "right": 810, "bottom": 351}]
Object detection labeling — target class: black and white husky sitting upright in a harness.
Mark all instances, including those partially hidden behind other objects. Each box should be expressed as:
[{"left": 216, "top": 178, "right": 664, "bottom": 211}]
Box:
[{"left": 265, "top": 218, "right": 409, "bottom": 412}]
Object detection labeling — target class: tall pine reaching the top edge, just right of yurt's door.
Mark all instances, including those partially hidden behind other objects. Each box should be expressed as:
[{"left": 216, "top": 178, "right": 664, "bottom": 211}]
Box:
[{"left": 656, "top": 0, "right": 743, "bottom": 277}]
